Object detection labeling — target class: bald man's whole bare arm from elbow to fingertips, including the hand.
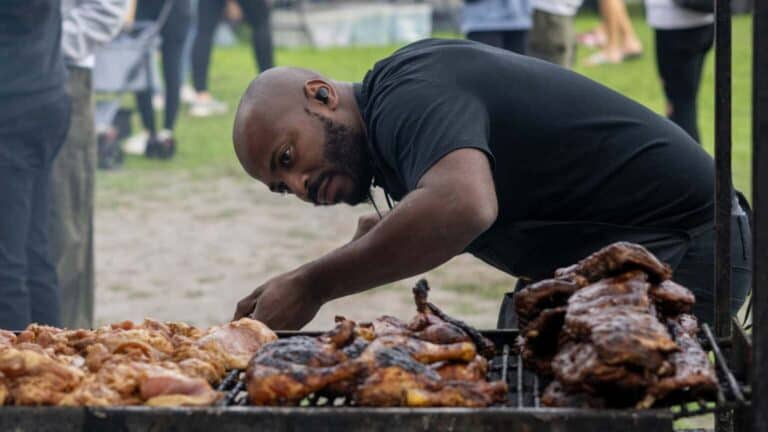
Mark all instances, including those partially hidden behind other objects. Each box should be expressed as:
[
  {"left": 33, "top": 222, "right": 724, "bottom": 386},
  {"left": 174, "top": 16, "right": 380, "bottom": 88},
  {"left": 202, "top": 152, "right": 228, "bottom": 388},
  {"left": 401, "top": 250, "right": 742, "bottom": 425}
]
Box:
[{"left": 235, "top": 148, "right": 498, "bottom": 329}]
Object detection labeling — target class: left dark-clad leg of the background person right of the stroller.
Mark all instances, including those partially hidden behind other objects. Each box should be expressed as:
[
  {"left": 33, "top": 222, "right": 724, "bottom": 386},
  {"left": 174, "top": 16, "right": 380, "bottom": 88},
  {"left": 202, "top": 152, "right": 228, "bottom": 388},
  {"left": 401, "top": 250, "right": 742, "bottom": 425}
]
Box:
[{"left": 192, "top": 0, "right": 224, "bottom": 93}]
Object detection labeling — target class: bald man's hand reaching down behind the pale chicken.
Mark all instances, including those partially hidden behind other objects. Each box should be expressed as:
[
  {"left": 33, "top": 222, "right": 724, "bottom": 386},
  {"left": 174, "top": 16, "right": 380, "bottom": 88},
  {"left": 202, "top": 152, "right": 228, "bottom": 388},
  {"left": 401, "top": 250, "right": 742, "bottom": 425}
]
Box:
[{"left": 234, "top": 272, "right": 322, "bottom": 330}]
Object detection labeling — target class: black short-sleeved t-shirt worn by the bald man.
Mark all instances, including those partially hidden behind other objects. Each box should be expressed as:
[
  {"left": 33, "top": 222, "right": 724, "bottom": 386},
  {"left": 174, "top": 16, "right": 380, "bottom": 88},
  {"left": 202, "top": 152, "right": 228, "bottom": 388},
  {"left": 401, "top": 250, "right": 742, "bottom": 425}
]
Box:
[{"left": 357, "top": 40, "right": 714, "bottom": 278}]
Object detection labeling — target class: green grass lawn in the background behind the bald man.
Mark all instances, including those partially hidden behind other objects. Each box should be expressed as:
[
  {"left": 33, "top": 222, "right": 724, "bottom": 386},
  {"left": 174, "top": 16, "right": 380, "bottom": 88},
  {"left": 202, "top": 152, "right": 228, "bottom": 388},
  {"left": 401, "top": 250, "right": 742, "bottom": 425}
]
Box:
[{"left": 98, "top": 10, "right": 752, "bottom": 201}]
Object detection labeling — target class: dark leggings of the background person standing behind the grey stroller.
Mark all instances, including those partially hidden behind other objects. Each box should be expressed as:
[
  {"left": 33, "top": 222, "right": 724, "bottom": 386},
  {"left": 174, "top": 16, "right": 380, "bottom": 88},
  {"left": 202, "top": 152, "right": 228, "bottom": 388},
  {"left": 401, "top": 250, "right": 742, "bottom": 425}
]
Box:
[{"left": 136, "top": 0, "right": 192, "bottom": 135}]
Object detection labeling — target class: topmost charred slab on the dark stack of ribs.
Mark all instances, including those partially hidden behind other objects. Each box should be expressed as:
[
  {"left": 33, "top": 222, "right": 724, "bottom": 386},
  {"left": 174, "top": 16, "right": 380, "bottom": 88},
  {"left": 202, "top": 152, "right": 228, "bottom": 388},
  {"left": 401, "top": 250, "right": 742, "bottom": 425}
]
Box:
[{"left": 555, "top": 242, "right": 672, "bottom": 283}]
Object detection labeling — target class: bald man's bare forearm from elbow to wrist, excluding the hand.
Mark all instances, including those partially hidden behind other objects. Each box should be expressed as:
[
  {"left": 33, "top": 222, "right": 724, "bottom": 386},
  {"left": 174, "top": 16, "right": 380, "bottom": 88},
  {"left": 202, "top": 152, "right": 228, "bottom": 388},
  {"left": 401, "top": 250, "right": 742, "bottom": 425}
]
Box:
[{"left": 306, "top": 148, "right": 498, "bottom": 302}]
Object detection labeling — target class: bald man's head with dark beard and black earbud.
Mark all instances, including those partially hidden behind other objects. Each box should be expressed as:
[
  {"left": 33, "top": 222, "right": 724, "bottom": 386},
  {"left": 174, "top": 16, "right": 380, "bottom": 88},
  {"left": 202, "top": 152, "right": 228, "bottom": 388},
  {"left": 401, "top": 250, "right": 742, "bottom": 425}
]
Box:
[{"left": 232, "top": 68, "right": 371, "bottom": 204}]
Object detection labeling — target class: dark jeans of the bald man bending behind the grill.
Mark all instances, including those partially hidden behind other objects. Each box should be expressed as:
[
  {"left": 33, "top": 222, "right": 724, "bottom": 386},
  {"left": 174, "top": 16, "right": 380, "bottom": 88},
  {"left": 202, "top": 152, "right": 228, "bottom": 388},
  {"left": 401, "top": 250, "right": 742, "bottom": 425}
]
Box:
[{"left": 498, "top": 209, "right": 752, "bottom": 328}]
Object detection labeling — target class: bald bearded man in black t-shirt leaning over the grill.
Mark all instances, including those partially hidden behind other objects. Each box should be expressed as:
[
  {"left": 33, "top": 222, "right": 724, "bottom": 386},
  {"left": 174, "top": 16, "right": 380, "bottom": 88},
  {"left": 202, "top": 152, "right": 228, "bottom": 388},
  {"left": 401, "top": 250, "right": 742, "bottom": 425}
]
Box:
[{"left": 233, "top": 40, "right": 751, "bottom": 329}]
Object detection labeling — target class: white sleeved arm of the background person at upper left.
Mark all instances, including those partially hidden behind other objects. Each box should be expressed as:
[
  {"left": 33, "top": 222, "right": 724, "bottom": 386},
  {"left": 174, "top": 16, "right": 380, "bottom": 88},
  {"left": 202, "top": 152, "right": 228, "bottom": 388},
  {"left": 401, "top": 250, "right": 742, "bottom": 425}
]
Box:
[{"left": 61, "top": 0, "right": 128, "bottom": 62}]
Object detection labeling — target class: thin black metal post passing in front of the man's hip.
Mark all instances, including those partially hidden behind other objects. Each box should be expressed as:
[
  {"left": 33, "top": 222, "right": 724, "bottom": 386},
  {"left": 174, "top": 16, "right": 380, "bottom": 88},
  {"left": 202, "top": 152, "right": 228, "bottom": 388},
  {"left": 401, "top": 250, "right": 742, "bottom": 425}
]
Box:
[{"left": 715, "top": 0, "right": 734, "bottom": 432}]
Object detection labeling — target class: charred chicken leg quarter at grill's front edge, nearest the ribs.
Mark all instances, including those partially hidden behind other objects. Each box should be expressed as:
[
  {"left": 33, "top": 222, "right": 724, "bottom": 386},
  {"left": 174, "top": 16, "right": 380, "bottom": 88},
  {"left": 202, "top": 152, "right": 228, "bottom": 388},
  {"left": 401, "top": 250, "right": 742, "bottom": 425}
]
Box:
[{"left": 354, "top": 344, "right": 507, "bottom": 407}]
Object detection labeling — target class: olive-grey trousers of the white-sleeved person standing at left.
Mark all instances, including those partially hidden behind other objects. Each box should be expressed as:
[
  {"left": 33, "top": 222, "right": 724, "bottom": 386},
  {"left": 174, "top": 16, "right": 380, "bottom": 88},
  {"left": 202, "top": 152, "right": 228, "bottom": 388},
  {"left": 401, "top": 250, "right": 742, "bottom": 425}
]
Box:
[{"left": 49, "top": 67, "right": 96, "bottom": 328}]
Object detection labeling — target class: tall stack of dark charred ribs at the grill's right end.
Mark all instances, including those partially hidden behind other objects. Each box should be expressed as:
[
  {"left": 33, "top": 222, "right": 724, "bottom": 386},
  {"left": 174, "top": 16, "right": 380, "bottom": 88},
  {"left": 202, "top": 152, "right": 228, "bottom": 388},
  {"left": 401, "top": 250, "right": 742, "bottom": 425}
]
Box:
[{"left": 515, "top": 242, "right": 717, "bottom": 408}]
